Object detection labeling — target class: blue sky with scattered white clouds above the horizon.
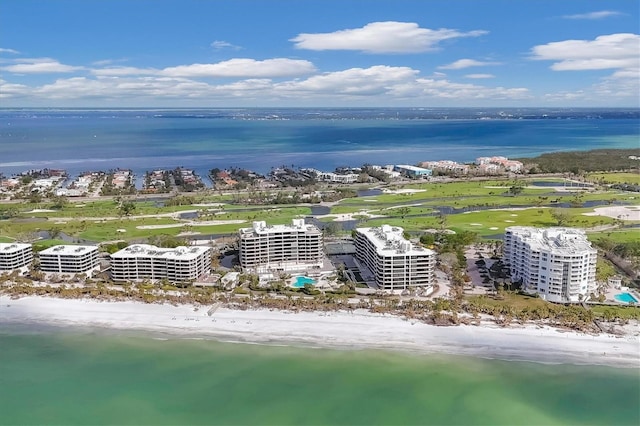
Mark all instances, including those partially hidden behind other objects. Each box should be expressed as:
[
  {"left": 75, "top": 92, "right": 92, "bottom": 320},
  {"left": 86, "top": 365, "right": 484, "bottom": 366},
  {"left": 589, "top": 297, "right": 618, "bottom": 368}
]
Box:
[{"left": 0, "top": 0, "right": 640, "bottom": 107}]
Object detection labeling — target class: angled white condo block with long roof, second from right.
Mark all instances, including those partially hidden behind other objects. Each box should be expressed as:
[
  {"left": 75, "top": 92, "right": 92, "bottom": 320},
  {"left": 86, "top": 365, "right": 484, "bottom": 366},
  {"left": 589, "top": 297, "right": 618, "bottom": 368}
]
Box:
[{"left": 355, "top": 225, "right": 436, "bottom": 290}]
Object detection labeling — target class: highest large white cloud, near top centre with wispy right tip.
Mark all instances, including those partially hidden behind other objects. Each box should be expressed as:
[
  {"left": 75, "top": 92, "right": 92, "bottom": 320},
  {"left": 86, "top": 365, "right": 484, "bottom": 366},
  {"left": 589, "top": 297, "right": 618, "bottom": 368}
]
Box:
[{"left": 290, "top": 21, "right": 487, "bottom": 53}]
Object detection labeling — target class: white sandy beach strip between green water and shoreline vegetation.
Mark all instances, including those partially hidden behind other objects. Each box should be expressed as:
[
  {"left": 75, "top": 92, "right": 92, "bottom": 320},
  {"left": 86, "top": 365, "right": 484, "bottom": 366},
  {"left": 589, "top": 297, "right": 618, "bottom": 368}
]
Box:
[{"left": 0, "top": 296, "right": 640, "bottom": 368}]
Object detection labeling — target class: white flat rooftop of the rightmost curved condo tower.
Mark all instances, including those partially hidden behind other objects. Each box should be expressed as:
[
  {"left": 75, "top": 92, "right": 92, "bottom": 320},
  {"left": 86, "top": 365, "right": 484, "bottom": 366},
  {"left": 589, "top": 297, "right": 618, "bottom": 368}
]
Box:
[{"left": 505, "top": 226, "right": 596, "bottom": 255}]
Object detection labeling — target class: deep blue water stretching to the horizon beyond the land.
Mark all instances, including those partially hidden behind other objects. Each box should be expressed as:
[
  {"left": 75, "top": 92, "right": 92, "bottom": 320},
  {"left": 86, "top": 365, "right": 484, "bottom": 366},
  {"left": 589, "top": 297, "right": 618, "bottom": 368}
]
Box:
[{"left": 0, "top": 108, "right": 640, "bottom": 181}]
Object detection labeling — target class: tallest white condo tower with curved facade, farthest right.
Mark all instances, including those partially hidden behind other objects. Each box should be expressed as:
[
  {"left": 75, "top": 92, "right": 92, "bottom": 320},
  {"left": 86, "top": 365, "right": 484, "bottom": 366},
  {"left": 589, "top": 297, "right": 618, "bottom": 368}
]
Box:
[{"left": 503, "top": 226, "right": 598, "bottom": 303}]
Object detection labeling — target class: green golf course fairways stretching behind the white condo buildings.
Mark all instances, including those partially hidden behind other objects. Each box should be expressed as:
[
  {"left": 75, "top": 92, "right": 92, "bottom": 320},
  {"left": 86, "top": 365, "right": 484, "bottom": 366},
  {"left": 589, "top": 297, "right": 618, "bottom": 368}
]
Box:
[{"left": 0, "top": 174, "right": 640, "bottom": 242}]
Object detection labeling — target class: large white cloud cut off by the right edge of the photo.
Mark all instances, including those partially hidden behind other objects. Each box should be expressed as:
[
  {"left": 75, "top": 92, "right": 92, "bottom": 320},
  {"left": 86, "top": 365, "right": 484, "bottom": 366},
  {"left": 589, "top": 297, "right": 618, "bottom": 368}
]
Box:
[{"left": 532, "top": 33, "right": 640, "bottom": 71}]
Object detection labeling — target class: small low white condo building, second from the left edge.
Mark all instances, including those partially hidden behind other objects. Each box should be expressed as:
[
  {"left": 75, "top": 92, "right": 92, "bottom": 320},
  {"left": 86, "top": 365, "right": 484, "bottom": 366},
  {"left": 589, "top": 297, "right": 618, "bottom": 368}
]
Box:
[{"left": 38, "top": 245, "right": 99, "bottom": 275}]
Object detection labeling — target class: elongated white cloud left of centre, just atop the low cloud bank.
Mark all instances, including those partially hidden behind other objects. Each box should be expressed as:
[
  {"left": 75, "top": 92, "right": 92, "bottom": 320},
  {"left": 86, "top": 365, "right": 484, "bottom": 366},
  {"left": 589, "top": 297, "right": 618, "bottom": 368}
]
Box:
[{"left": 160, "top": 58, "right": 316, "bottom": 78}]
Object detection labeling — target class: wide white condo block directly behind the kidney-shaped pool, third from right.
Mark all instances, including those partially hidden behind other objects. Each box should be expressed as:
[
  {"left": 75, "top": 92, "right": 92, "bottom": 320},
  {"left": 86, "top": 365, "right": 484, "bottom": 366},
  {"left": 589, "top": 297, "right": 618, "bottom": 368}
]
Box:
[{"left": 239, "top": 219, "right": 324, "bottom": 273}]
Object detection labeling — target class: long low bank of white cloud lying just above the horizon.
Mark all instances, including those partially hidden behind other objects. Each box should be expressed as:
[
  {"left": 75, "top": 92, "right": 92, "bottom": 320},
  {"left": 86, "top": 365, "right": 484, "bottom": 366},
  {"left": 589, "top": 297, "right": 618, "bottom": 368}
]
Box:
[{"left": 0, "top": 65, "right": 528, "bottom": 105}]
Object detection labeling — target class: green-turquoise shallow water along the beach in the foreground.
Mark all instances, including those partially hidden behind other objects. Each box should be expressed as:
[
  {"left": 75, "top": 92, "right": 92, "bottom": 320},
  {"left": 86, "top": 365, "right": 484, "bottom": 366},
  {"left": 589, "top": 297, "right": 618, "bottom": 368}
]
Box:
[{"left": 0, "top": 325, "right": 640, "bottom": 425}]
